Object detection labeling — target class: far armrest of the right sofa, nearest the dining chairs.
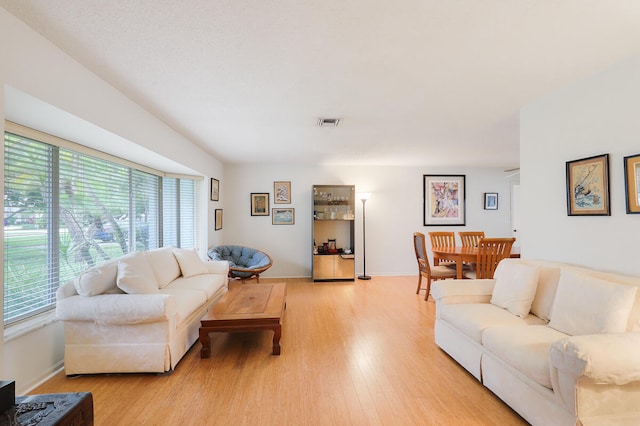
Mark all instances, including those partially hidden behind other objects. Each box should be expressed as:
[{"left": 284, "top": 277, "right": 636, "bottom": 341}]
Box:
[{"left": 431, "top": 280, "right": 495, "bottom": 304}]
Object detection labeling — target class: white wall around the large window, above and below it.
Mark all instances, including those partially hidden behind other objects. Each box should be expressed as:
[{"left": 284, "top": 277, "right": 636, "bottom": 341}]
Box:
[{"left": 0, "top": 8, "right": 224, "bottom": 394}]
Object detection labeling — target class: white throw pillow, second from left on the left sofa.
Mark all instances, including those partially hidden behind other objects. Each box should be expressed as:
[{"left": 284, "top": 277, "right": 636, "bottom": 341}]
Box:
[{"left": 117, "top": 251, "right": 158, "bottom": 294}]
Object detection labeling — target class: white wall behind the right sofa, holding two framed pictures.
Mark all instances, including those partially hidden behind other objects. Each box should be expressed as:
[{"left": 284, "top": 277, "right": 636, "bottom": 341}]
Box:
[{"left": 520, "top": 57, "right": 640, "bottom": 275}]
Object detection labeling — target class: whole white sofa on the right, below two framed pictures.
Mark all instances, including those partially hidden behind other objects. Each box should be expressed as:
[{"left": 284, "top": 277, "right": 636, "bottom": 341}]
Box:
[{"left": 431, "top": 259, "right": 640, "bottom": 425}]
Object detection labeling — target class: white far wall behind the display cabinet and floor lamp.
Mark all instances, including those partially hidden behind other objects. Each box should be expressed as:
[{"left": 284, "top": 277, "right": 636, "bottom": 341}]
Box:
[{"left": 221, "top": 164, "right": 517, "bottom": 277}]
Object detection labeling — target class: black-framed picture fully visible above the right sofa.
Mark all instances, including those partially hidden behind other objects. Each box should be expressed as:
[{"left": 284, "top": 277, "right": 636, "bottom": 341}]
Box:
[{"left": 567, "top": 154, "right": 611, "bottom": 216}]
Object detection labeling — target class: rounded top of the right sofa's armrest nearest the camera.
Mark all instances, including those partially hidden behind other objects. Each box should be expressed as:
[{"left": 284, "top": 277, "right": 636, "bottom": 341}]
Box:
[{"left": 550, "top": 332, "right": 640, "bottom": 385}]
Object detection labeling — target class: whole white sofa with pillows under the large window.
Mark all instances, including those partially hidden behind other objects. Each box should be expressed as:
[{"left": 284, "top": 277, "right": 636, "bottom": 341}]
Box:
[{"left": 56, "top": 247, "right": 229, "bottom": 375}]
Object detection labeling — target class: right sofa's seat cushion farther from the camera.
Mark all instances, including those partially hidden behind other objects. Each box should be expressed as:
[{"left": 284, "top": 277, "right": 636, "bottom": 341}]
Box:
[{"left": 439, "top": 303, "right": 545, "bottom": 343}]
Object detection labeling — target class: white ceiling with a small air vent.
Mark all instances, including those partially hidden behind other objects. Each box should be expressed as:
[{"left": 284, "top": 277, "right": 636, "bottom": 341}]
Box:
[{"left": 0, "top": 0, "right": 640, "bottom": 168}]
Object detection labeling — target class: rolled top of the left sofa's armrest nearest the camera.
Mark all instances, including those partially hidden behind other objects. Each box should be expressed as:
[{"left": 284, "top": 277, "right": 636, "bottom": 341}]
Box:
[{"left": 56, "top": 294, "right": 177, "bottom": 324}]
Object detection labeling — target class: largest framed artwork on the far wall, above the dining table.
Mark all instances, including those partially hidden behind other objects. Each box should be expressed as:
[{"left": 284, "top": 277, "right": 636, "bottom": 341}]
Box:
[{"left": 422, "top": 175, "right": 466, "bottom": 226}]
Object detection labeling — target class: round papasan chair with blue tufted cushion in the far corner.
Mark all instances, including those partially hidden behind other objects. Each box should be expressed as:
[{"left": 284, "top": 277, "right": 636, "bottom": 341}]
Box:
[{"left": 207, "top": 245, "right": 273, "bottom": 282}]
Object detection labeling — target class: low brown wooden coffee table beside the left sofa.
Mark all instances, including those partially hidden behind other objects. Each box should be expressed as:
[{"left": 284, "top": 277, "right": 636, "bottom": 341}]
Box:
[{"left": 200, "top": 283, "right": 287, "bottom": 358}]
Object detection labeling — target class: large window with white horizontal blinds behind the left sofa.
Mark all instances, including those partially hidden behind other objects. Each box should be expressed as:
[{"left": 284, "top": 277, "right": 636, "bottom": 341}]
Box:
[{"left": 4, "top": 128, "right": 196, "bottom": 325}]
